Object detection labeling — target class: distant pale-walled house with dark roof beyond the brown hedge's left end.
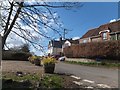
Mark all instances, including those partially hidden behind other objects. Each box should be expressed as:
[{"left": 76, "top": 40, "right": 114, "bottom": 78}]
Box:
[{"left": 48, "top": 38, "right": 79, "bottom": 55}]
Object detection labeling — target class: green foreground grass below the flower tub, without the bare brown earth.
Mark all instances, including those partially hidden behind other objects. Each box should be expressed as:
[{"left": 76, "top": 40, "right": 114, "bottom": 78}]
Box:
[{"left": 2, "top": 73, "right": 62, "bottom": 89}]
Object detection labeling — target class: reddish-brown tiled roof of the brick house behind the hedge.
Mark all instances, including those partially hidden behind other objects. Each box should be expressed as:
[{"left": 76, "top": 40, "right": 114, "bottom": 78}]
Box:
[{"left": 80, "top": 20, "right": 120, "bottom": 39}]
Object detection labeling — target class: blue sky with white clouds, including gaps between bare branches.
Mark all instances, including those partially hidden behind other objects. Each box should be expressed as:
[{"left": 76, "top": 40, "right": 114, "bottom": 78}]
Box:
[{"left": 0, "top": 2, "right": 120, "bottom": 55}]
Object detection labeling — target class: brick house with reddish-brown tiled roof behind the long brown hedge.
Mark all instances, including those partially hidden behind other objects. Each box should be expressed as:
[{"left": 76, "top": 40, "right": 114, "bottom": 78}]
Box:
[{"left": 79, "top": 20, "right": 120, "bottom": 43}]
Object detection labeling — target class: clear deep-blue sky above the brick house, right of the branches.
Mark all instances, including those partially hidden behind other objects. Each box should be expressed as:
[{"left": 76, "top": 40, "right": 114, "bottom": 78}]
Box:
[{"left": 35, "top": 2, "right": 118, "bottom": 55}]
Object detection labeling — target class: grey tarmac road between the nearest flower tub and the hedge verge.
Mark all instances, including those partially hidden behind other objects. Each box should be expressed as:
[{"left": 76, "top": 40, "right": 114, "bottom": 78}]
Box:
[{"left": 55, "top": 62, "right": 118, "bottom": 88}]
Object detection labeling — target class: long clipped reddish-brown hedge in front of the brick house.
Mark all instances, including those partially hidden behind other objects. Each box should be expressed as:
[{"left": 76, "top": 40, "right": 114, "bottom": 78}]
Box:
[{"left": 64, "top": 40, "right": 120, "bottom": 59}]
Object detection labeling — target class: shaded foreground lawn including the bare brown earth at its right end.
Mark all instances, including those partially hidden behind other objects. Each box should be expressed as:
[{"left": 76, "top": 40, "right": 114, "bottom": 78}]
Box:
[{"left": 2, "top": 72, "right": 79, "bottom": 90}]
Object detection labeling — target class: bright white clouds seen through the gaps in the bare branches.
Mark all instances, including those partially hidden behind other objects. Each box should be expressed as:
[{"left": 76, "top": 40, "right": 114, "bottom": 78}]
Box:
[{"left": 0, "top": 0, "right": 62, "bottom": 53}]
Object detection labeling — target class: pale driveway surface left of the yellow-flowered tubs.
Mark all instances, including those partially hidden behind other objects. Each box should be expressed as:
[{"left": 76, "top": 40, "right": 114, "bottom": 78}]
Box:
[{"left": 2, "top": 60, "right": 44, "bottom": 74}]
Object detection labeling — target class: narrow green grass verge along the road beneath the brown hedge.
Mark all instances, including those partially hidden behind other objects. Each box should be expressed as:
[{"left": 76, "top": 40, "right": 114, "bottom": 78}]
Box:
[{"left": 65, "top": 61, "right": 120, "bottom": 67}]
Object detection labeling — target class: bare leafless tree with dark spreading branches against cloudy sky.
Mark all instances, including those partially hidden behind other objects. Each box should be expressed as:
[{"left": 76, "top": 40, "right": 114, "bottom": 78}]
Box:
[{"left": 1, "top": 0, "right": 81, "bottom": 52}]
